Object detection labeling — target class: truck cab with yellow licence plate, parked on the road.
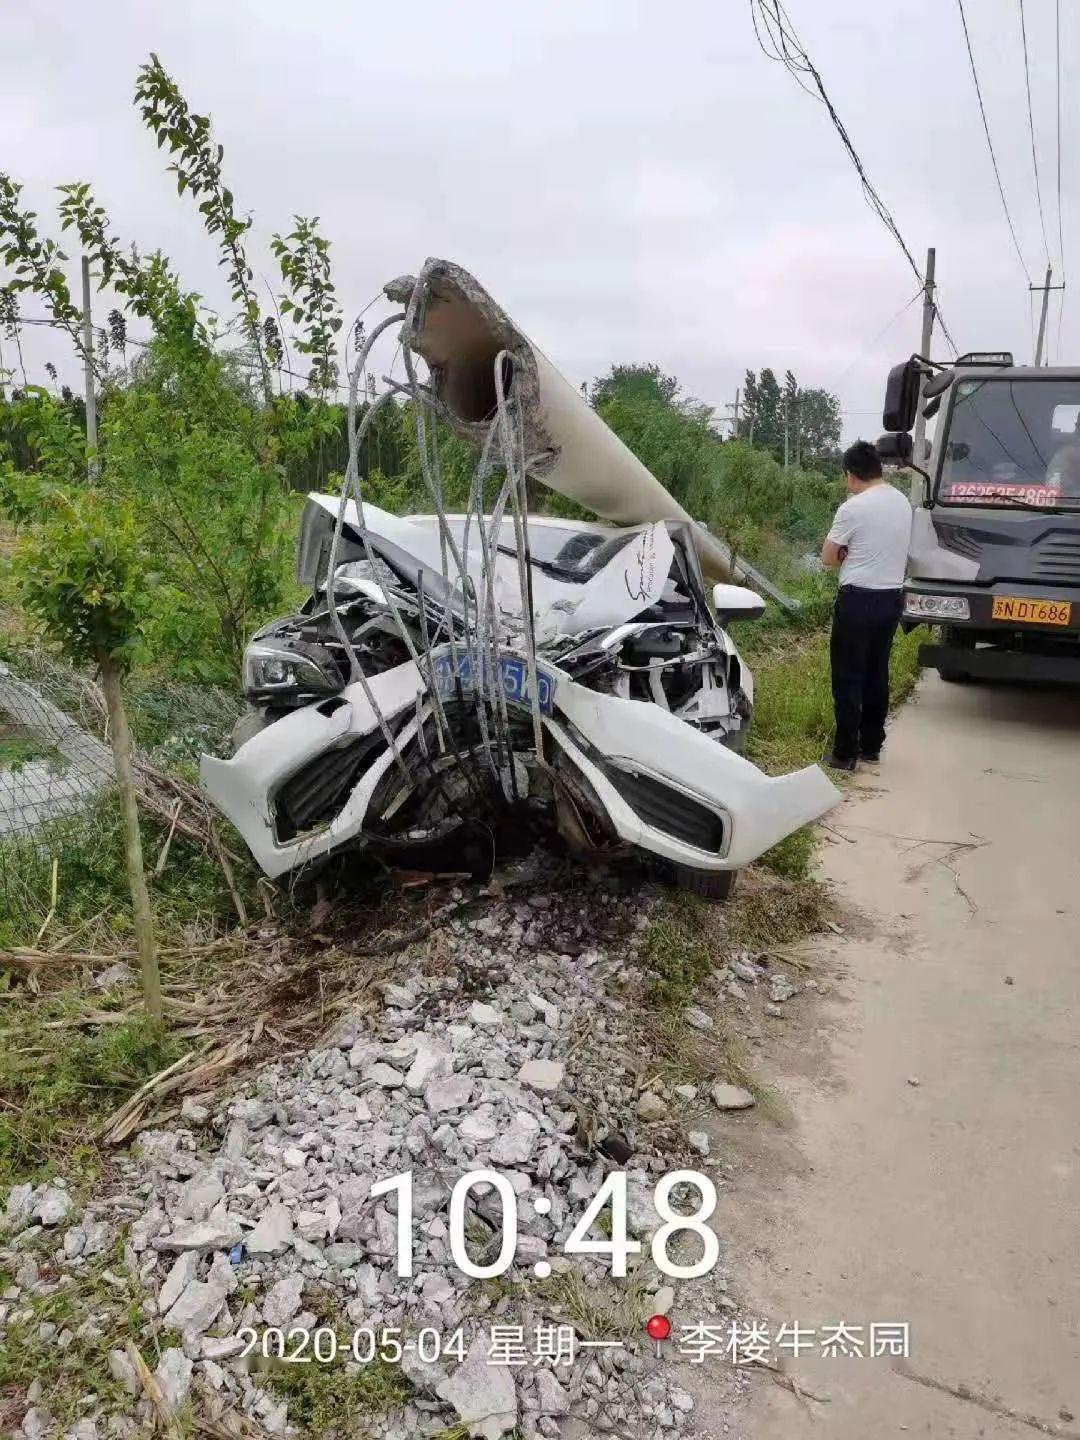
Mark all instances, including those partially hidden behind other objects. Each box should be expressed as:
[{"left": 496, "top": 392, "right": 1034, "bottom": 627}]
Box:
[{"left": 878, "top": 353, "right": 1080, "bottom": 683}]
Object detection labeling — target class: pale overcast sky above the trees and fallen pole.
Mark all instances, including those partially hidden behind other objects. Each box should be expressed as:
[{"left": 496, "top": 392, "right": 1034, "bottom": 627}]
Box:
[{"left": 0, "top": 0, "right": 1080, "bottom": 438}]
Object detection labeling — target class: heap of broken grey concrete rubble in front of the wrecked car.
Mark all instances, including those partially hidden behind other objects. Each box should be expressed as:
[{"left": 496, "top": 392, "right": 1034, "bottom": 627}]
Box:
[{"left": 0, "top": 858, "right": 794, "bottom": 1440}]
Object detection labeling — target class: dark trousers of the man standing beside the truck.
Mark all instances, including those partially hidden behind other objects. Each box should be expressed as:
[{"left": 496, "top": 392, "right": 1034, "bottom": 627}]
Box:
[{"left": 829, "top": 585, "right": 904, "bottom": 760}]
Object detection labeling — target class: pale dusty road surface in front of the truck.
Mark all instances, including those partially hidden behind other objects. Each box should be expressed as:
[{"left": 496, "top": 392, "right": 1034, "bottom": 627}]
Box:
[{"left": 721, "top": 677, "right": 1080, "bottom": 1440}]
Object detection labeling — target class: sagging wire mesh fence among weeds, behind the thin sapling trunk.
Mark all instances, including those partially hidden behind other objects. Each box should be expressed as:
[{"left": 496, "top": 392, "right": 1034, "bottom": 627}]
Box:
[{"left": 0, "top": 651, "right": 239, "bottom": 948}]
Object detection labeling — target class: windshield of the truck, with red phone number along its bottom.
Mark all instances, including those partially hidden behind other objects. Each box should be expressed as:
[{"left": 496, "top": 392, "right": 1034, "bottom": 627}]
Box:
[{"left": 937, "top": 377, "right": 1080, "bottom": 510}]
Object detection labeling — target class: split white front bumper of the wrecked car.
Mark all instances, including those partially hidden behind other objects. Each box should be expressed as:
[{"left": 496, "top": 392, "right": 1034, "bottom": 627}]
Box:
[{"left": 202, "top": 664, "right": 840, "bottom": 877}]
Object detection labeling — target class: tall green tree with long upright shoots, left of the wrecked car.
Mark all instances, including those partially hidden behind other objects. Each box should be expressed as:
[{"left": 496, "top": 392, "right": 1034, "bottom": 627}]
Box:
[{"left": 0, "top": 56, "right": 344, "bottom": 683}]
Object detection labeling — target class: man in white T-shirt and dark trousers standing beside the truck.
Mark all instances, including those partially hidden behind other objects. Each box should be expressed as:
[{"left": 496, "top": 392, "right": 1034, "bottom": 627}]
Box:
[{"left": 821, "top": 441, "right": 912, "bottom": 770}]
